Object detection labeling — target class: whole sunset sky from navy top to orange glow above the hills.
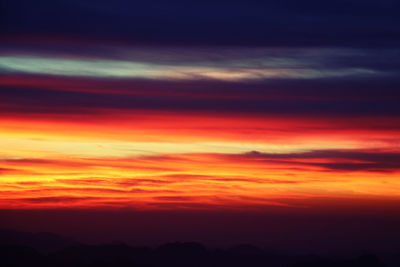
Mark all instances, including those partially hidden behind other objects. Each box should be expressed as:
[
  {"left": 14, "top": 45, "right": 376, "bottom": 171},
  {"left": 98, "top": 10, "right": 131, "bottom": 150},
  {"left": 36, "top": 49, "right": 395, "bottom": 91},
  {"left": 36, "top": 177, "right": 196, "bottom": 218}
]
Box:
[{"left": 0, "top": 0, "right": 400, "bottom": 254}]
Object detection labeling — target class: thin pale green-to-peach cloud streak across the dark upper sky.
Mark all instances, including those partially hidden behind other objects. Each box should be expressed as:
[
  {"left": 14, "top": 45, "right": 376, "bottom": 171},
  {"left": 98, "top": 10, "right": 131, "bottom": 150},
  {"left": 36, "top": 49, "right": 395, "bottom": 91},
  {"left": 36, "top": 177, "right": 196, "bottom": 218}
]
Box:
[{"left": 0, "top": 55, "right": 380, "bottom": 81}]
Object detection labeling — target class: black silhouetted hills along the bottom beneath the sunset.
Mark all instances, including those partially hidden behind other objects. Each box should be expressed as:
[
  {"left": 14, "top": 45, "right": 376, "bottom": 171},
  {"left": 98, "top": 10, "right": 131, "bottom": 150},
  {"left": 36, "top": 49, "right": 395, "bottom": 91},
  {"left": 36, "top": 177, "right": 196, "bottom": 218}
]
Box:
[{"left": 0, "top": 230, "right": 395, "bottom": 267}]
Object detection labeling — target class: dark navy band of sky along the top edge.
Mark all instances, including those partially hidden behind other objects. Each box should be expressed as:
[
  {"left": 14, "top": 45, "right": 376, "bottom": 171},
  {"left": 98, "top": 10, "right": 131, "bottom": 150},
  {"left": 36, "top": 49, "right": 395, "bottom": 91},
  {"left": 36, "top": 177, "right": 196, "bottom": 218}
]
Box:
[{"left": 1, "top": 0, "right": 400, "bottom": 47}]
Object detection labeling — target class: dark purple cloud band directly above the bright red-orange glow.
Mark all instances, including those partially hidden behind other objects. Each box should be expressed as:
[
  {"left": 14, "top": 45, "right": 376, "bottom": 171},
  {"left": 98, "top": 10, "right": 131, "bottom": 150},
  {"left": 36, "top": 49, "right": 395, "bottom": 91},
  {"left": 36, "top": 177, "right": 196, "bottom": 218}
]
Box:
[{"left": 0, "top": 83, "right": 400, "bottom": 116}]
